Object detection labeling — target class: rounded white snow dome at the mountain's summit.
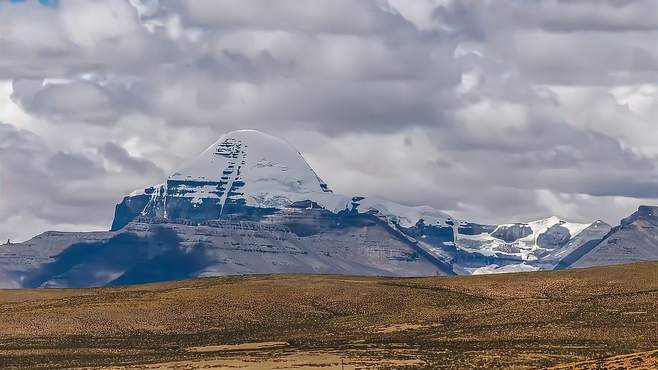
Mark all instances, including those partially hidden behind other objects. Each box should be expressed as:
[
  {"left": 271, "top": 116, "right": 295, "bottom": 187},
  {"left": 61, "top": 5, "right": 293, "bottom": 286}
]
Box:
[{"left": 168, "top": 130, "right": 330, "bottom": 207}]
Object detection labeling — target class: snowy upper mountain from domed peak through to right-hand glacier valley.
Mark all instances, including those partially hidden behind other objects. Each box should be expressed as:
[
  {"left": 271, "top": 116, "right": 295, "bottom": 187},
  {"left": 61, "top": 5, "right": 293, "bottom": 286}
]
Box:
[{"left": 112, "top": 130, "right": 612, "bottom": 273}]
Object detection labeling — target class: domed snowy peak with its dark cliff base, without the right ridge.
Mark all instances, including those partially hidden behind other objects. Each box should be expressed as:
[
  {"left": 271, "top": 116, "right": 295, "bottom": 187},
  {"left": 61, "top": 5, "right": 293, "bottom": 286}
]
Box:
[{"left": 112, "top": 130, "right": 334, "bottom": 230}]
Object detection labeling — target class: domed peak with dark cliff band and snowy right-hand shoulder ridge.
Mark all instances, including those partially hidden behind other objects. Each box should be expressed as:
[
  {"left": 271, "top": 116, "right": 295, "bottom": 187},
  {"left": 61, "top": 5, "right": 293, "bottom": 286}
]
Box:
[{"left": 118, "top": 130, "right": 452, "bottom": 230}]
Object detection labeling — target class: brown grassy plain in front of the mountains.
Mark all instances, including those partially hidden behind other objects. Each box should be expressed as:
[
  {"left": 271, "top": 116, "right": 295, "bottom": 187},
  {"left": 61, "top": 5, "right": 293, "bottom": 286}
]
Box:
[{"left": 0, "top": 263, "right": 658, "bottom": 369}]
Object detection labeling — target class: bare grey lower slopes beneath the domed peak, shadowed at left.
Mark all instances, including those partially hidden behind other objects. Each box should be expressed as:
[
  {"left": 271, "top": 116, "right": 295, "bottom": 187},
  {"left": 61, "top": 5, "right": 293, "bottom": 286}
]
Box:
[{"left": 7, "top": 208, "right": 453, "bottom": 287}]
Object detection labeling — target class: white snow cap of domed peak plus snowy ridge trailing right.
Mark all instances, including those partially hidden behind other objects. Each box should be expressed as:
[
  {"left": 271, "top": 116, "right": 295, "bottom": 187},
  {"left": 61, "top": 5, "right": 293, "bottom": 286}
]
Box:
[{"left": 163, "top": 130, "right": 451, "bottom": 227}]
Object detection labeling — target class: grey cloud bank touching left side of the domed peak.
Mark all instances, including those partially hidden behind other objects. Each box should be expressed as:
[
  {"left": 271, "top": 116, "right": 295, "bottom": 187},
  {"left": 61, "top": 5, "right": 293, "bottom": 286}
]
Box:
[{"left": 0, "top": 123, "right": 164, "bottom": 239}]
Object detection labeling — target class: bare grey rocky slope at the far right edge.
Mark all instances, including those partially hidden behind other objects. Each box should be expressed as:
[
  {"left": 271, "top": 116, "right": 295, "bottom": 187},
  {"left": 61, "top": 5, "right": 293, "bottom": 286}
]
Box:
[{"left": 570, "top": 206, "right": 658, "bottom": 268}]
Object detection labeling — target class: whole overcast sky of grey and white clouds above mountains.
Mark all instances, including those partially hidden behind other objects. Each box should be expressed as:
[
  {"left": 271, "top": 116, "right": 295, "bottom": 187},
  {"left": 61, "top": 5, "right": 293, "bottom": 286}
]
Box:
[{"left": 0, "top": 0, "right": 658, "bottom": 240}]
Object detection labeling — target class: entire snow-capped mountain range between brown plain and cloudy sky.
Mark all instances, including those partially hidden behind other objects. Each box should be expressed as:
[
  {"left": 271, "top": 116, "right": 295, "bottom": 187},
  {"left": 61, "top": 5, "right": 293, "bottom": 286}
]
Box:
[{"left": 0, "top": 130, "right": 658, "bottom": 287}]
